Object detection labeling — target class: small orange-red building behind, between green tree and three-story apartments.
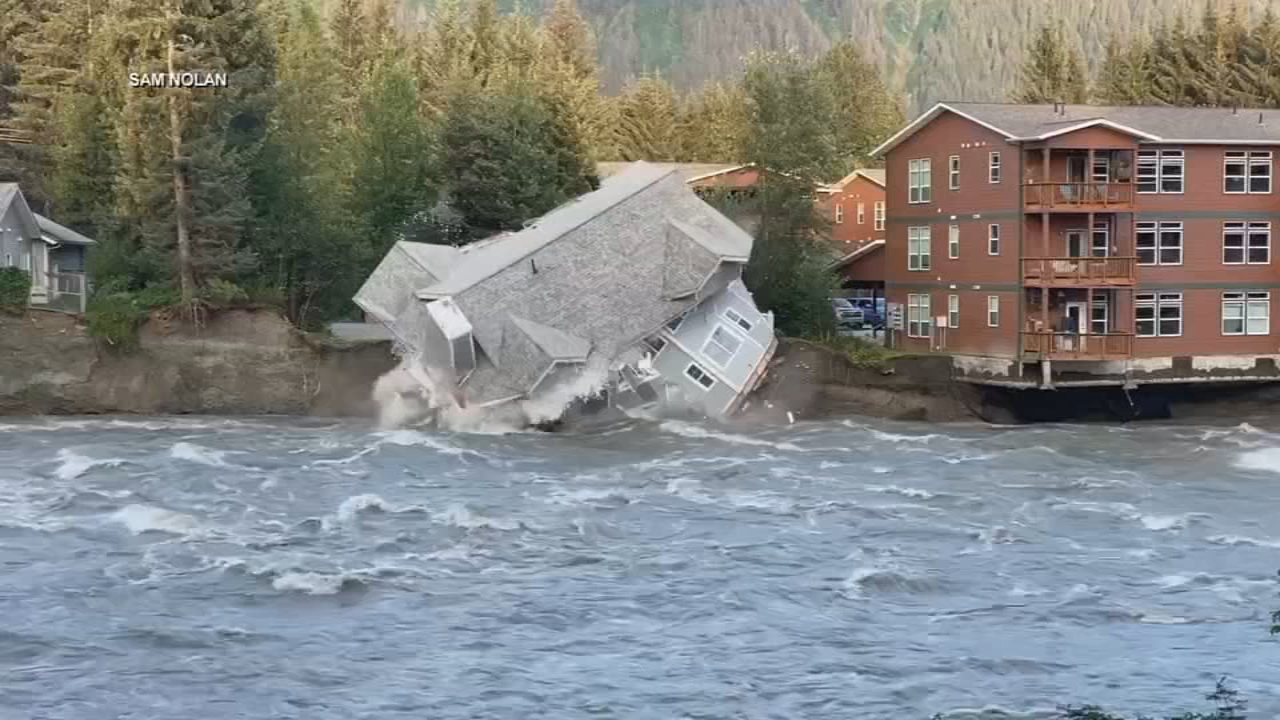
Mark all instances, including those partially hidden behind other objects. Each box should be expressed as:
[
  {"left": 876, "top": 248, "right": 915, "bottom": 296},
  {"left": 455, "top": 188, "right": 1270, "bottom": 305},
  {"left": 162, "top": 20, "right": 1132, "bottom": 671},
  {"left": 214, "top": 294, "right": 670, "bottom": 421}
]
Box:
[{"left": 818, "top": 169, "right": 884, "bottom": 291}]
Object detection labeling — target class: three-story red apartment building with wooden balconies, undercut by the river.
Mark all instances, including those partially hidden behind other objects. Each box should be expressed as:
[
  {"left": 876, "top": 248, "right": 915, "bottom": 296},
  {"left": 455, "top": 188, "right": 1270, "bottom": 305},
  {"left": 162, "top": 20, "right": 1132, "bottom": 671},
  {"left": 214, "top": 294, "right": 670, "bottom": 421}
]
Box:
[{"left": 876, "top": 102, "right": 1280, "bottom": 387}]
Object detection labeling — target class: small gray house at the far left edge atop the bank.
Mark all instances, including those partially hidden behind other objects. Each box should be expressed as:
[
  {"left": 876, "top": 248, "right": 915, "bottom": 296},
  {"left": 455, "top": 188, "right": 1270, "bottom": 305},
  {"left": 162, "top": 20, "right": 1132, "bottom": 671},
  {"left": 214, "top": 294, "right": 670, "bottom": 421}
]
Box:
[{"left": 0, "top": 183, "right": 96, "bottom": 311}]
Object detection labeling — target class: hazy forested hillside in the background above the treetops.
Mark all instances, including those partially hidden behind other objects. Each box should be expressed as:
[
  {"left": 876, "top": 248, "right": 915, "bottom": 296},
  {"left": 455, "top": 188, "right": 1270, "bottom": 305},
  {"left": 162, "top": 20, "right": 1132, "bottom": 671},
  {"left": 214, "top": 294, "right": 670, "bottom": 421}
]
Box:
[{"left": 394, "top": 0, "right": 1280, "bottom": 111}]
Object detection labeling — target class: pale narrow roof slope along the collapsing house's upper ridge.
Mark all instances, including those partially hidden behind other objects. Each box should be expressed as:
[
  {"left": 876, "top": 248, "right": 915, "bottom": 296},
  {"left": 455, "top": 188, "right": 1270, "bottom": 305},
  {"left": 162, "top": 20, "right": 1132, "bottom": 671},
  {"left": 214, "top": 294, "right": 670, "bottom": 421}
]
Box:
[{"left": 417, "top": 163, "right": 675, "bottom": 299}]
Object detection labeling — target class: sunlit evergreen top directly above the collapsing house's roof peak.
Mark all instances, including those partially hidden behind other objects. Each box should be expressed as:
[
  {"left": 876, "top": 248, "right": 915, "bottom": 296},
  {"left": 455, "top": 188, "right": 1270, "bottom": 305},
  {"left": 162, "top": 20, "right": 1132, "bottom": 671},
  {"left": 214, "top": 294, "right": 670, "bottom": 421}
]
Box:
[{"left": 616, "top": 76, "right": 680, "bottom": 163}]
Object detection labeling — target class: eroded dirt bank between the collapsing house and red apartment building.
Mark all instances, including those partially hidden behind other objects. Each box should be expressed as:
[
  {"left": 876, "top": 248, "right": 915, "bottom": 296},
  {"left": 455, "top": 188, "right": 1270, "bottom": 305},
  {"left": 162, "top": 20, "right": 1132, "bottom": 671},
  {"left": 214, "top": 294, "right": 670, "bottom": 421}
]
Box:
[{"left": 745, "top": 340, "right": 1011, "bottom": 423}]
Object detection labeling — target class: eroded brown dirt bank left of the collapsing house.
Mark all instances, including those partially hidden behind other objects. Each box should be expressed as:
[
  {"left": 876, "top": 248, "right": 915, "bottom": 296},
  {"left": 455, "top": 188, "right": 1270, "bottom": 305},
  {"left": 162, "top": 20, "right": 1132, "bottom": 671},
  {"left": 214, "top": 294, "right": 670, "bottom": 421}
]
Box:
[{"left": 0, "top": 310, "right": 396, "bottom": 416}]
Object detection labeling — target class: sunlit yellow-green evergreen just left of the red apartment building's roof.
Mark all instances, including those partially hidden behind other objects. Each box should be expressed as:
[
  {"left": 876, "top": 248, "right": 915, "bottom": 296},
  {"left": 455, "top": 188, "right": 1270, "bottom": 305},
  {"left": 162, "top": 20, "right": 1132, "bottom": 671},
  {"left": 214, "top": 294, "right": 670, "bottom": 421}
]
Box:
[{"left": 818, "top": 40, "right": 906, "bottom": 177}]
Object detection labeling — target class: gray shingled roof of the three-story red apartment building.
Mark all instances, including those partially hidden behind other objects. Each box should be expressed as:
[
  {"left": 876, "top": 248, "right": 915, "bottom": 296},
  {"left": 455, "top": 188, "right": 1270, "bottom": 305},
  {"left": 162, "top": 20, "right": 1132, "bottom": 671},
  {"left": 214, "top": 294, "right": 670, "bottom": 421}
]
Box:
[{"left": 874, "top": 102, "right": 1280, "bottom": 155}]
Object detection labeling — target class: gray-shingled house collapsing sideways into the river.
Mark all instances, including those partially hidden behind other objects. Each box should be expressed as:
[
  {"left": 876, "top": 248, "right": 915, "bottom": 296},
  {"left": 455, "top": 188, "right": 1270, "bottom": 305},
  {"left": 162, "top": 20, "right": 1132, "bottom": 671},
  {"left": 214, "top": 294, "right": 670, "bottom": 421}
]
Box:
[{"left": 355, "top": 163, "right": 777, "bottom": 418}]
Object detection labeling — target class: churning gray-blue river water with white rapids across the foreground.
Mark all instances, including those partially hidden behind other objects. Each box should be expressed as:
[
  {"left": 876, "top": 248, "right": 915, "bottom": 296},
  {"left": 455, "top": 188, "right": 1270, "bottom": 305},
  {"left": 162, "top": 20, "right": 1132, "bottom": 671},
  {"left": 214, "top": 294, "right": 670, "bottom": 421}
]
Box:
[{"left": 0, "top": 419, "right": 1280, "bottom": 720}]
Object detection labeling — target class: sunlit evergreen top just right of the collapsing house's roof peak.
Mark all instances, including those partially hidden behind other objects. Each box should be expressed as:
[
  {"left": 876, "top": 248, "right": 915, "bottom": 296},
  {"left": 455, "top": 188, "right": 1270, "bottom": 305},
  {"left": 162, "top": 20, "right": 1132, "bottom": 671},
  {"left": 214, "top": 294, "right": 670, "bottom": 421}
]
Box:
[{"left": 677, "top": 83, "right": 746, "bottom": 163}]
